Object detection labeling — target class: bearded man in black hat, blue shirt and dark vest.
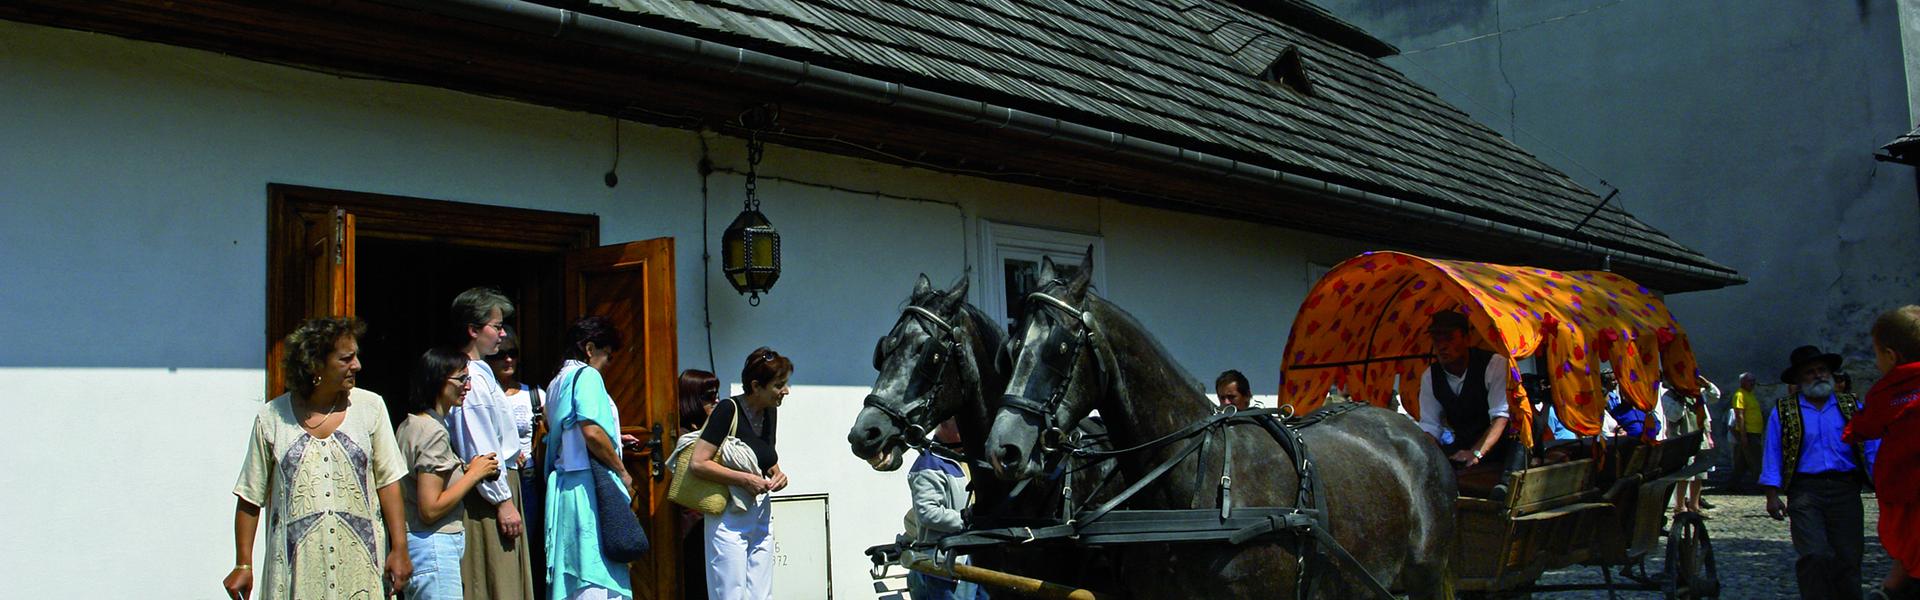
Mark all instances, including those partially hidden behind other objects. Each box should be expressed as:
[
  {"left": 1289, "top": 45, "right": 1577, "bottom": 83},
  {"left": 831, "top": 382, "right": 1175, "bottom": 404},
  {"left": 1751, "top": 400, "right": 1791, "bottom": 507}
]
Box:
[{"left": 1761, "top": 346, "right": 1872, "bottom": 598}]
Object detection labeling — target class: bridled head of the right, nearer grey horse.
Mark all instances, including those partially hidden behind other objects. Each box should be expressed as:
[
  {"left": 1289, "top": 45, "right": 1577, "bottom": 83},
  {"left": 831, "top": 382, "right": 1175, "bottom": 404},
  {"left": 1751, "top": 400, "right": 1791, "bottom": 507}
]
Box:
[{"left": 987, "top": 252, "right": 1108, "bottom": 479}]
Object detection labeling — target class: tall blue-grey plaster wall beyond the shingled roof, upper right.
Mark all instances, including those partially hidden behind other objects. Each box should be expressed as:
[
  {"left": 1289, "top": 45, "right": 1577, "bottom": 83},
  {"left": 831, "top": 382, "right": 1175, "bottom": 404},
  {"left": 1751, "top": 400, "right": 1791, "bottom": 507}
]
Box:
[{"left": 1321, "top": 0, "right": 1920, "bottom": 383}]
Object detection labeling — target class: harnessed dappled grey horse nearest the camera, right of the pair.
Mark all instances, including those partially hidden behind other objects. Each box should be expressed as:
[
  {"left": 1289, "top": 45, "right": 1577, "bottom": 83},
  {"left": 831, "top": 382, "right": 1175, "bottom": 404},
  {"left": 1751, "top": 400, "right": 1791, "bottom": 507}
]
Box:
[{"left": 987, "top": 256, "right": 1457, "bottom": 598}]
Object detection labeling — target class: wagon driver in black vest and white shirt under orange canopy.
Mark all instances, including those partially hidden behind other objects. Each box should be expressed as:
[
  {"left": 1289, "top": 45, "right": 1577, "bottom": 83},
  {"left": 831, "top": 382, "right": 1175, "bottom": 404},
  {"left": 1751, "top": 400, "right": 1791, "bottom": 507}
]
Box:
[{"left": 1419, "top": 310, "right": 1526, "bottom": 478}]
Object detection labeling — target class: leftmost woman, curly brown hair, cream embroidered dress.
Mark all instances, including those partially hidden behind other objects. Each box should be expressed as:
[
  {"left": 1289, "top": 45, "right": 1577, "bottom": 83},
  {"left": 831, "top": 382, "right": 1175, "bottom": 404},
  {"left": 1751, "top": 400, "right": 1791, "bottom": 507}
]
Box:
[{"left": 223, "top": 317, "right": 413, "bottom": 598}]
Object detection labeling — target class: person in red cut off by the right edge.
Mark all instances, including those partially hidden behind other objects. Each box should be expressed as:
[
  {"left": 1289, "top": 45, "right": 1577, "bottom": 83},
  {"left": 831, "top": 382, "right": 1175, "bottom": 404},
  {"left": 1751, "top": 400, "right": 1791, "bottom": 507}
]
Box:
[{"left": 1845, "top": 304, "right": 1920, "bottom": 598}]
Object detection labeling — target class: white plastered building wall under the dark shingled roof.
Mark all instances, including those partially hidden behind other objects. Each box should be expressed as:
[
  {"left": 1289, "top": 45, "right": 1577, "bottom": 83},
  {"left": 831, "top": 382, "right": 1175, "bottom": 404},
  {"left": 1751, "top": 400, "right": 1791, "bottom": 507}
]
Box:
[{"left": 0, "top": 21, "right": 1363, "bottom": 598}]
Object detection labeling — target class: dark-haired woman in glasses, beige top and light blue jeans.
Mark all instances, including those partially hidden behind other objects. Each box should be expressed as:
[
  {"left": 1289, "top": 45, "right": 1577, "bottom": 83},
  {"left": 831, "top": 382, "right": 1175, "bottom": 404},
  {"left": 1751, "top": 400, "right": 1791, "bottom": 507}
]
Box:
[{"left": 394, "top": 348, "right": 499, "bottom": 600}]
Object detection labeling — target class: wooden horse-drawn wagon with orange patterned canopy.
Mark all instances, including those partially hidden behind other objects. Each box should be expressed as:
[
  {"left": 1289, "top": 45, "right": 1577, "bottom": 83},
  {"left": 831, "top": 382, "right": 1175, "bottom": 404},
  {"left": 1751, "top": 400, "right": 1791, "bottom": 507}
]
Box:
[{"left": 1281, "top": 252, "right": 1718, "bottom": 598}]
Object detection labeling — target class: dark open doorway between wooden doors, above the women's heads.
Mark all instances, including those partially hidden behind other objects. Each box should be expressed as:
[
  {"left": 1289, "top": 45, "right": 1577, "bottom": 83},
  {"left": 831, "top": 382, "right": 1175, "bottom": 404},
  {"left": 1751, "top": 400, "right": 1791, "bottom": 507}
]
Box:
[{"left": 355, "top": 233, "right": 566, "bottom": 398}]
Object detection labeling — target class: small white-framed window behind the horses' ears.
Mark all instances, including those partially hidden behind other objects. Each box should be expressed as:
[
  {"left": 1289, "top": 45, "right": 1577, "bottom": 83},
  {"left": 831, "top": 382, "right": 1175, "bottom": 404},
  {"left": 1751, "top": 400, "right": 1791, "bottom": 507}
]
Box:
[{"left": 979, "top": 219, "right": 1106, "bottom": 331}]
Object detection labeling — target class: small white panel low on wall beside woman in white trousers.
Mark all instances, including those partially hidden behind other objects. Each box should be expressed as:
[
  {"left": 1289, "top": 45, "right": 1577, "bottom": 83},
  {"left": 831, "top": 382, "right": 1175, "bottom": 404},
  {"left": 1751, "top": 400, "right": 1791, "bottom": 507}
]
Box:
[{"left": 774, "top": 494, "right": 833, "bottom": 600}]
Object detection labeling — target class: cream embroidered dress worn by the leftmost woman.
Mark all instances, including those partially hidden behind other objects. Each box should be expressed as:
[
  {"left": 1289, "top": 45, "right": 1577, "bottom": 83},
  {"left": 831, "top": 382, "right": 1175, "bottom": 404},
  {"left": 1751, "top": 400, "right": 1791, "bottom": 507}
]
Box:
[{"left": 234, "top": 388, "right": 407, "bottom": 600}]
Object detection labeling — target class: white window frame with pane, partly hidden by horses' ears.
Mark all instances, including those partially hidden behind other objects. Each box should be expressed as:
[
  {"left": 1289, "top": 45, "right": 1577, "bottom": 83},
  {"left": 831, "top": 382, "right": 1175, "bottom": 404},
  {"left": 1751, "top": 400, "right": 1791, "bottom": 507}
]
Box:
[{"left": 973, "top": 219, "right": 1108, "bottom": 327}]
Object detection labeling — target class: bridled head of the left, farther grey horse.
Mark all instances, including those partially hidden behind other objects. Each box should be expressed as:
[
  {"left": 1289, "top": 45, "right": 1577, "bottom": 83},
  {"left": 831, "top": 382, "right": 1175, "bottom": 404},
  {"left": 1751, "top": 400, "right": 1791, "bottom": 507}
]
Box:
[{"left": 847, "top": 275, "right": 1000, "bottom": 471}]
